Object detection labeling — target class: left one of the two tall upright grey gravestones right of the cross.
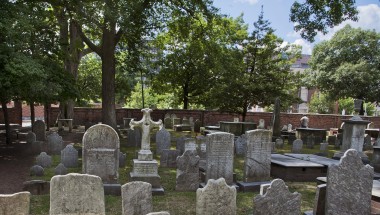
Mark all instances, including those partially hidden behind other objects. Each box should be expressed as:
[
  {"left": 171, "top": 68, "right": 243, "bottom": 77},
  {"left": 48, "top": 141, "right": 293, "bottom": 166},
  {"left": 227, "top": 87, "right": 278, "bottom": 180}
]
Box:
[{"left": 206, "top": 132, "right": 234, "bottom": 184}]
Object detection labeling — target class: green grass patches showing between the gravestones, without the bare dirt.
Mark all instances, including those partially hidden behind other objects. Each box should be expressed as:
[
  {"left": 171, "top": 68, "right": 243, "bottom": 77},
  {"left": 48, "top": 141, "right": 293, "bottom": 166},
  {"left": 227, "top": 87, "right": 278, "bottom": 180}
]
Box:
[{"left": 30, "top": 130, "right": 356, "bottom": 215}]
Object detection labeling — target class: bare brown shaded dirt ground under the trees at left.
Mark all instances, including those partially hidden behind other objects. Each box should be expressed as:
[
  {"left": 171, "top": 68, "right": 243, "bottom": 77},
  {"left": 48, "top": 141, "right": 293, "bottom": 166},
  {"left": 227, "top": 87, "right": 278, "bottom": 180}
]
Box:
[{"left": 0, "top": 127, "right": 84, "bottom": 194}]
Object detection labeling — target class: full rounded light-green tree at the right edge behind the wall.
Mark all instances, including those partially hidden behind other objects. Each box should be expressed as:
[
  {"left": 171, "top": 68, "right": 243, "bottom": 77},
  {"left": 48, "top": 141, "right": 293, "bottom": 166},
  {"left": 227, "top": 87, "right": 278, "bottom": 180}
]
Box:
[{"left": 308, "top": 25, "right": 380, "bottom": 114}]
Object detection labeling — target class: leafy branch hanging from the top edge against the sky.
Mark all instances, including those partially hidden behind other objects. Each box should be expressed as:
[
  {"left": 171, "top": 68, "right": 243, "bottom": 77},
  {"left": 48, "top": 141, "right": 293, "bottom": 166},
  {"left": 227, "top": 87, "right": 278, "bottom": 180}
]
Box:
[{"left": 290, "top": 0, "right": 358, "bottom": 42}]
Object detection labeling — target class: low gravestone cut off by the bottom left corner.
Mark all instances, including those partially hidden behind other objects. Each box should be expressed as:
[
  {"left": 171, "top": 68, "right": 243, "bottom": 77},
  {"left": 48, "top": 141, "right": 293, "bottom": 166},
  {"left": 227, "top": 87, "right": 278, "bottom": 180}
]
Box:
[{"left": 0, "top": 192, "right": 30, "bottom": 215}]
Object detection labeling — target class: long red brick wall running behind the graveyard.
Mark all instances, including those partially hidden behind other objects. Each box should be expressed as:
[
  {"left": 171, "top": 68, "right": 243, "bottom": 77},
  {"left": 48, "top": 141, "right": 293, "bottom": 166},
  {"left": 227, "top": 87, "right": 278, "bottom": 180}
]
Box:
[{"left": 50, "top": 108, "right": 380, "bottom": 129}]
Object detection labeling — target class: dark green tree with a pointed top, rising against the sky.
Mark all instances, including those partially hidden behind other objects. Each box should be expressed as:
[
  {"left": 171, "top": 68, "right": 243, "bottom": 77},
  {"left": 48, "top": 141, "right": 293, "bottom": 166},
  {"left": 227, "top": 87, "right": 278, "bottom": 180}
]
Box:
[{"left": 210, "top": 9, "right": 300, "bottom": 120}]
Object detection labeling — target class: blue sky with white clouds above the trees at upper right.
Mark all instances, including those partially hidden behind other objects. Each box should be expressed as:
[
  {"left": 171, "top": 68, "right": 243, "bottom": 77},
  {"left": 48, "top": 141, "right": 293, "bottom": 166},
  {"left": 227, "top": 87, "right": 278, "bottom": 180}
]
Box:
[{"left": 214, "top": 0, "right": 380, "bottom": 54}]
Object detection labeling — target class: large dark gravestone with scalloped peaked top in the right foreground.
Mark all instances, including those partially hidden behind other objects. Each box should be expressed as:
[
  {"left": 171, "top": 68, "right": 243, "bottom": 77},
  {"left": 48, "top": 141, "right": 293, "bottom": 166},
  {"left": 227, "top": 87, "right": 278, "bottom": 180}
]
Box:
[{"left": 325, "top": 149, "right": 374, "bottom": 215}]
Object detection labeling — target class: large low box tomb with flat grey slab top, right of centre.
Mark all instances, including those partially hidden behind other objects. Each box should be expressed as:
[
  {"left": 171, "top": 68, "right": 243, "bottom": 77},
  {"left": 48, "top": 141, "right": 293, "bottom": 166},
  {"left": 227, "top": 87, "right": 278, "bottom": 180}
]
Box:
[{"left": 271, "top": 154, "right": 327, "bottom": 182}]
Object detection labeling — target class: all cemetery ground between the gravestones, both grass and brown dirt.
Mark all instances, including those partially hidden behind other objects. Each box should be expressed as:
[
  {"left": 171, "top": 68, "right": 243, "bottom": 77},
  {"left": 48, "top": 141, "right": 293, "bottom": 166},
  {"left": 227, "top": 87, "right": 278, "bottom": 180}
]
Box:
[{"left": 0, "top": 127, "right": 371, "bottom": 215}]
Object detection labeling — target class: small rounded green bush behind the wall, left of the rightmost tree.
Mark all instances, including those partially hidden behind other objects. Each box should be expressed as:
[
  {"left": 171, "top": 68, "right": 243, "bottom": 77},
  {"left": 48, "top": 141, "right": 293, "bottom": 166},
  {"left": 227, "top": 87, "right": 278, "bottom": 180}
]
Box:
[{"left": 309, "top": 92, "right": 335, "bottom": 114}]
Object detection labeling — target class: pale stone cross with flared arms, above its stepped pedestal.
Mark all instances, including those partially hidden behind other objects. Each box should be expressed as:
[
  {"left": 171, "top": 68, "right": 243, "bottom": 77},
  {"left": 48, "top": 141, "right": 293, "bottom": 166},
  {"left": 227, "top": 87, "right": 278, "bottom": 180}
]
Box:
[{"left": 129, "top": 108, "right": 162, "bottom": 150}]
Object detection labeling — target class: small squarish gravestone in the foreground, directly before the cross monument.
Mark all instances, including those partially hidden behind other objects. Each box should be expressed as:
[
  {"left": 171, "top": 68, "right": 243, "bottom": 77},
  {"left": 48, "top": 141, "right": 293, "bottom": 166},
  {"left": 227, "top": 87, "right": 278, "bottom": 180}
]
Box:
[{"left": 121, "top": 181, "right": 153, "bottom": 215}]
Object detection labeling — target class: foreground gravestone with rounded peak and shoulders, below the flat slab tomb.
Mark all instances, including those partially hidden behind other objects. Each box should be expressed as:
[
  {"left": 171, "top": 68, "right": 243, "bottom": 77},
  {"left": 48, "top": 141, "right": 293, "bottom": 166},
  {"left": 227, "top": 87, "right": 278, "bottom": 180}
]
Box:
[{"left": 253, "top": 179, "right": 301, "bottom": 215}]
